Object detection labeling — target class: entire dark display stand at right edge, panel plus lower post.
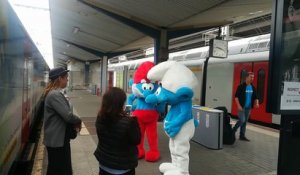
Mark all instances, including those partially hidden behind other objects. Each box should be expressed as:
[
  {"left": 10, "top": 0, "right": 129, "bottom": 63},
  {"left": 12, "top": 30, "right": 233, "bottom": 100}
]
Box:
[{"left": 267, "top": 0, "right": 300, "bottom": 175}]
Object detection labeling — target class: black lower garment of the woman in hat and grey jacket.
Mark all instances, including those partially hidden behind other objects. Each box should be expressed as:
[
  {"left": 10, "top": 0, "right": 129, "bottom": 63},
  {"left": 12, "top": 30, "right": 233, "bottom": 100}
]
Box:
[{"left": 47, "top": 142, "right": 72, "bottom": 175}]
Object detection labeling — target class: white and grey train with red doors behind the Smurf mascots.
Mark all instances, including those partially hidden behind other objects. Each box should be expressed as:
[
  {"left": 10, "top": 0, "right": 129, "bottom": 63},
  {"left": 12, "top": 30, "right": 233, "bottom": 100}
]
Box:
[{"left": 108, "top": 34, "right": 281, "bottom": 128}]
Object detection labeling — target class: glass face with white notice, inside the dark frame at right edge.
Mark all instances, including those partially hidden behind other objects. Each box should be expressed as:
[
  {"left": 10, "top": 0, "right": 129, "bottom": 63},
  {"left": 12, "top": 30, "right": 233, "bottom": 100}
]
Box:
[{"left": 280, "top": 0, "right": 300, "bottom": 110}]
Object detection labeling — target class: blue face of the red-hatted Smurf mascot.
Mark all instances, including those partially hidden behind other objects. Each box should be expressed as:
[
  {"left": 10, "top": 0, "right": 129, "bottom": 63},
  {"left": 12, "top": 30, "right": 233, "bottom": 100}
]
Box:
[{"left": 132, "top": 82, "right": 158, "bottom": 98}]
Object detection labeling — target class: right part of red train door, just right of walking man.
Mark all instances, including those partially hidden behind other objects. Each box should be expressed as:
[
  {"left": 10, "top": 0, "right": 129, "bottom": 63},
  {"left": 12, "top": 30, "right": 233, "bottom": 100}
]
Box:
[{"left": 250, "top": 62, "right": 272, "bottom": 123}]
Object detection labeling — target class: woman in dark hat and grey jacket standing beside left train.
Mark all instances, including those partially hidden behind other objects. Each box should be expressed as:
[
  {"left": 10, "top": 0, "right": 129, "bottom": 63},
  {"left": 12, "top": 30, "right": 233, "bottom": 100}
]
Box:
[{"left": 43, "top": 67, "right": 81, "bottom": 175}]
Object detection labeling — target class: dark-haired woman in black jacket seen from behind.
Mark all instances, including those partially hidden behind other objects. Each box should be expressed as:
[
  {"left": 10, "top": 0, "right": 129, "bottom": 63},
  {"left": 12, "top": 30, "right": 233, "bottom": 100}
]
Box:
[{"left": 94, "top": 87, "right": 140, "bottom": 175}]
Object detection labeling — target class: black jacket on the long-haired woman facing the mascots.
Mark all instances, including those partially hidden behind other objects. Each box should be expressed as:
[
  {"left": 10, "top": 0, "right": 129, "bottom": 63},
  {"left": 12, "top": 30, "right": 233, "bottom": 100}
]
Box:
[{"left": 94, "top": 117, "right": 140, "bottom": 170}]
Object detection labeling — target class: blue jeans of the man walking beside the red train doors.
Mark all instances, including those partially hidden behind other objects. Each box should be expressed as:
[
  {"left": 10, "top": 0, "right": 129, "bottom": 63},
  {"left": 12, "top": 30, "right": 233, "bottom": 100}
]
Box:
[{"left": 233, "top": 108, "right": 251, "bottom": 137}]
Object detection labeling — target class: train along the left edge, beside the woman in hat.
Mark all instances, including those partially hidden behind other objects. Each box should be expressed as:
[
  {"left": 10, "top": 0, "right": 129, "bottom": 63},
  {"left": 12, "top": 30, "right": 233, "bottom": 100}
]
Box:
[{"left": 0, "top": 1, "right": 49, "bottom": 175}]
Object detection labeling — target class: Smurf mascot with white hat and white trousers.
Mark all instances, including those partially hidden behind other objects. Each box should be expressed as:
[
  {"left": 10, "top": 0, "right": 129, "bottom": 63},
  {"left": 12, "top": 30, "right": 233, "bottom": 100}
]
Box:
[{"left": 146, "top": 61, "right": 198, "bottom": 175}]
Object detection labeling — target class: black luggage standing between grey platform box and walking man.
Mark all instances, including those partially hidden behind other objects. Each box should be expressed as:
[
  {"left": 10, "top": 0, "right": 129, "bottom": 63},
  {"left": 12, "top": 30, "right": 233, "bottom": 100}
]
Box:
[{"left": 215, "top": 106, "right": 235, "bottom": 145}]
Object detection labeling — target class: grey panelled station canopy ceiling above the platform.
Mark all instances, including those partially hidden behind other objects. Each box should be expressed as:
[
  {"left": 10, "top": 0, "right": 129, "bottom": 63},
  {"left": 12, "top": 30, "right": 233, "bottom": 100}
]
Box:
[{"left": 49, "top": 0, "right": 272, "bottom": 67}]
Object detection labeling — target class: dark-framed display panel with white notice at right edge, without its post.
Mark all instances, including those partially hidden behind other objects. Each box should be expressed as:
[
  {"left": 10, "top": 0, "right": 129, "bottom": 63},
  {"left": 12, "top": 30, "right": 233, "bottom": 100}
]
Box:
[{"left": 268, "top": 0, "right": 300, "bottom": 114}]
